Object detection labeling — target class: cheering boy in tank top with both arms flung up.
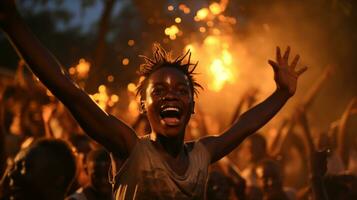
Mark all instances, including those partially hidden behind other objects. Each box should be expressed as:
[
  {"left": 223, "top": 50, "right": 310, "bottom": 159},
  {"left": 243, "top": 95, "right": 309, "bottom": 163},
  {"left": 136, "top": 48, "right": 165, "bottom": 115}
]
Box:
[{"left": 0, "top": 0, "right": 306, "bottom": 199}]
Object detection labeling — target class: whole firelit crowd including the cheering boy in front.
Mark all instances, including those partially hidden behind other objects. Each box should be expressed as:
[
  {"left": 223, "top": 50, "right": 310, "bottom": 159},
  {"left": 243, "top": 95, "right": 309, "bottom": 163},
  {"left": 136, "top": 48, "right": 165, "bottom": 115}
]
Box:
[{"left": 0, "top": 1, "right": 357, "bottom": 200}]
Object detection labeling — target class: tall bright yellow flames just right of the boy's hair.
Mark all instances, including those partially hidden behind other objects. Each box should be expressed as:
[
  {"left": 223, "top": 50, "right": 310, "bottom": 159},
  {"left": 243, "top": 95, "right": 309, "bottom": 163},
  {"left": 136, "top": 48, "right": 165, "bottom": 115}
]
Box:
[{"left": 172, "top": 0, "right": 239, "bottom": 92}]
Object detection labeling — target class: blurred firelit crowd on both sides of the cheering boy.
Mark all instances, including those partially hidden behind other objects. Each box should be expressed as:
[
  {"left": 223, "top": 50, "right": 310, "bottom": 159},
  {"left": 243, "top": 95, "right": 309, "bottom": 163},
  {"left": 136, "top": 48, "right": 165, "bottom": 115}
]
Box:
[{"left": 0, "top": 58, "right": 357, "bottom": 200}]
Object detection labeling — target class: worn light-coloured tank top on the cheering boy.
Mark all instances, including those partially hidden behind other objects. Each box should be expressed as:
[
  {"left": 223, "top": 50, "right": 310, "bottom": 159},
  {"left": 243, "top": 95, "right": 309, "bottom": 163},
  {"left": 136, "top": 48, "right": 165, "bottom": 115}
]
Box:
[{"left": 114, "top": 137, "right": 210, "bottom": 200}]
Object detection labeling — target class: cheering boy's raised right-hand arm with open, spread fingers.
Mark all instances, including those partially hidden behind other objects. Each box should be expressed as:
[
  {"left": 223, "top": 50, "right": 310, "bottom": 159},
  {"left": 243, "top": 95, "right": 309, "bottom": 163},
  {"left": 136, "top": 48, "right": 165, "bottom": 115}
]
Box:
[{"left": 201, "top": 47, "right": 307, "bottom": 162}]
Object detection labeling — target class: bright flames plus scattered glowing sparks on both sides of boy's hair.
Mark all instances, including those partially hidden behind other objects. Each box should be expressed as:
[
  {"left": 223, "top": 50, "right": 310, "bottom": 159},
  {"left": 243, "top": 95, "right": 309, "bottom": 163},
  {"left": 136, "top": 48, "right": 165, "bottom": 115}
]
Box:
[{"left": 69, "top": 0, "right": 239, "bottom": 117}]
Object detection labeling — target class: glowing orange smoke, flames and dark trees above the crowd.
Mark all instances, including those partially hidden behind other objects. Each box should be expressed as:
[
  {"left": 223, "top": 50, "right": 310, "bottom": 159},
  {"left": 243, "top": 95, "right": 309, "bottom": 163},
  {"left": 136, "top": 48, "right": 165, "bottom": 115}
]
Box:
[{"left": 0, "top": 0, "right": 357, "bottom": 132}]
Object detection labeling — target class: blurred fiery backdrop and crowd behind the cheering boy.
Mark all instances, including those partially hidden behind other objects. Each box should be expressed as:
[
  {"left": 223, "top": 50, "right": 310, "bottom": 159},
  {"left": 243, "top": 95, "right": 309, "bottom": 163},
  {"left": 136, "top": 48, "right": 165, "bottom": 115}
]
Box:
[{"left": 0, "top": 0, "right": 357, "bottom": 199}]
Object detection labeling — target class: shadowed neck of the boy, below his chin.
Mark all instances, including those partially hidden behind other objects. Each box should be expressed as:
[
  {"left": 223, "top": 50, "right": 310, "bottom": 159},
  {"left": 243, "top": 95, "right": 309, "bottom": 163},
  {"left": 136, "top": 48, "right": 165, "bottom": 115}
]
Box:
[{"left": 151, "top": 133, "right": 184, "bottom": 157}]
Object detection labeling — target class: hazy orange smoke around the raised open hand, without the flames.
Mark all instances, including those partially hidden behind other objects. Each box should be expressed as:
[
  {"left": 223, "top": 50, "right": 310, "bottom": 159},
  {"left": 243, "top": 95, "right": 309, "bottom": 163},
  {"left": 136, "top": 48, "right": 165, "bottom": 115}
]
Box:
[{"left": 181, "top": 0, "right": 357, "bottom": 131}]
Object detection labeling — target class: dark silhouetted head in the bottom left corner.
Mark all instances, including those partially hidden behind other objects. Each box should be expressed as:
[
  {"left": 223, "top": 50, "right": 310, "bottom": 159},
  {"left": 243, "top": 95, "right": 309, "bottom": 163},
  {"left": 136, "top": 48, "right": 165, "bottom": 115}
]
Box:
[{"left": 0, "top": 139, "right": 76, "bottom": 200}]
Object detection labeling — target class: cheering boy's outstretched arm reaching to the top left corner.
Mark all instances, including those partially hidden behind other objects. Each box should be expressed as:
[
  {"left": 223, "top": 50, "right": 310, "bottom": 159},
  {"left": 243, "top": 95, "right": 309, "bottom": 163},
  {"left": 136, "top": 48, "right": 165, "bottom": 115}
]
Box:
[{"left": 0, "top": 0, "right": 137, "bottom": 157}]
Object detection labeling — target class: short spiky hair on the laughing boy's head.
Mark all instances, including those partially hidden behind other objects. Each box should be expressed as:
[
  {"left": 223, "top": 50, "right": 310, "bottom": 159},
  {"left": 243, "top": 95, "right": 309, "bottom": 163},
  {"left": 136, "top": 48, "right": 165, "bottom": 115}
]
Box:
[{"left": 136, "top": 43, "right": 203, "bottom": 99}]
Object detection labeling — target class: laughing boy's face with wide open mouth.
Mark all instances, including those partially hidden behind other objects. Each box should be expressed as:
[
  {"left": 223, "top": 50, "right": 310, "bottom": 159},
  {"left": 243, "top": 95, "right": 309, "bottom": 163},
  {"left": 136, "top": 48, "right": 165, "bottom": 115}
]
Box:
[{"left": 144, "top": 67, "right": 194, "bottom": 137}]
